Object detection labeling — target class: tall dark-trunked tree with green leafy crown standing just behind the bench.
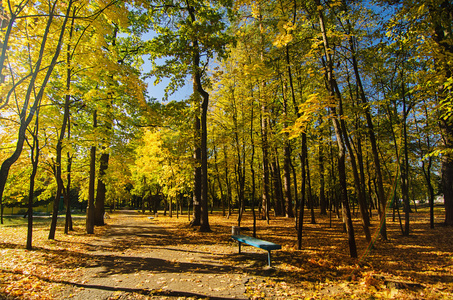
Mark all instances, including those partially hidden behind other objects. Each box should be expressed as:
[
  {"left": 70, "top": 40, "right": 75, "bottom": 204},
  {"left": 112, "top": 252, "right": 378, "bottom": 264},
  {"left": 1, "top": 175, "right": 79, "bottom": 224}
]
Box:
[{"left": 146, "top": 0, "right": 229, "bottom": 231}]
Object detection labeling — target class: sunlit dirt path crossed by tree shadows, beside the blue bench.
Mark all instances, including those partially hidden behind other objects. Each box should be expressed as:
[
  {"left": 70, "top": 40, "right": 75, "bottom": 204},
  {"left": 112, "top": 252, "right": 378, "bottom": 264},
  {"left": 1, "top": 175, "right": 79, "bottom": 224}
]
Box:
[{"left": 57, "top": 211, "right": 272, "bottom": 299}]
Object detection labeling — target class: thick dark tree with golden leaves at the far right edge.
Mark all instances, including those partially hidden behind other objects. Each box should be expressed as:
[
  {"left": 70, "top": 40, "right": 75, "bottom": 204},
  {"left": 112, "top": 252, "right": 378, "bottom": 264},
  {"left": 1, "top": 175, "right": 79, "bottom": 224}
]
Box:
[{"left": 385, "top": 0, "right": 453, "bottom": 225}]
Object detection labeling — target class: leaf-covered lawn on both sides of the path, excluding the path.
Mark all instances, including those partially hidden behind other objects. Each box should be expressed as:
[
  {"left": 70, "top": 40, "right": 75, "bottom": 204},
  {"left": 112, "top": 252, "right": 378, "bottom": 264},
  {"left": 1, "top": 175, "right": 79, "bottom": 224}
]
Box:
[{"left": 0, "top": 207, "right": 453, "bottom": 299}]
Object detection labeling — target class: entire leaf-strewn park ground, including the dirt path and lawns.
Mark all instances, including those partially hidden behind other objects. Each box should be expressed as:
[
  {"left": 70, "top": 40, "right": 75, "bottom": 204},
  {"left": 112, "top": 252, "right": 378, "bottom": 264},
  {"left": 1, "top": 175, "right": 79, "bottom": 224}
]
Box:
[{"left": 0, "top": 208, "right": 453, "bottom": 299}]
